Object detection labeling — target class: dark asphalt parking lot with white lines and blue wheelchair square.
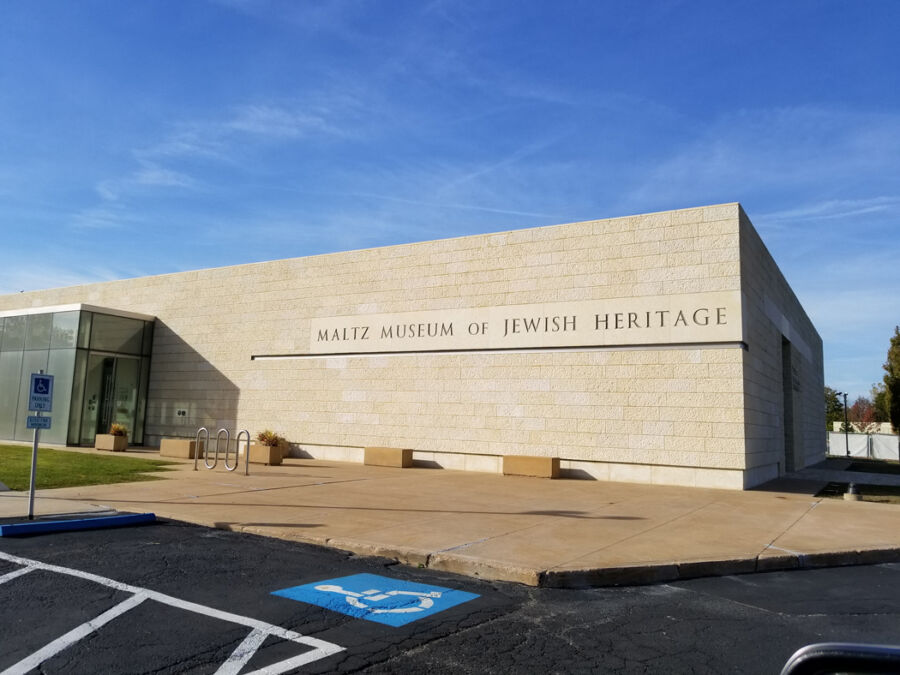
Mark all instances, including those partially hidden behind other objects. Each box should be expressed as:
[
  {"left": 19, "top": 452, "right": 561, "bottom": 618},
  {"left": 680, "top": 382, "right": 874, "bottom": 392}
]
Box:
[{"left": 0, "top": 522, "right": 900, "bottom": 673}]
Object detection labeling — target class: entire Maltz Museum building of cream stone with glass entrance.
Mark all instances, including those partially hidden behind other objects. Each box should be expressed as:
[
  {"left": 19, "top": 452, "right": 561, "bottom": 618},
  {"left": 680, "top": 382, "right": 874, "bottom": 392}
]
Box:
[{"left": 0, "top": 203, "right": 825, "bottom": 489}]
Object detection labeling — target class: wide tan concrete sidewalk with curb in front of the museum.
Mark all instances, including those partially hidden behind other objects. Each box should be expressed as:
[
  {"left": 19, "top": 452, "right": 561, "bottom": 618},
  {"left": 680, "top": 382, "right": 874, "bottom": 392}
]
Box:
[{"left": 0, "top": 459, "right": 900, "bottom": 587}]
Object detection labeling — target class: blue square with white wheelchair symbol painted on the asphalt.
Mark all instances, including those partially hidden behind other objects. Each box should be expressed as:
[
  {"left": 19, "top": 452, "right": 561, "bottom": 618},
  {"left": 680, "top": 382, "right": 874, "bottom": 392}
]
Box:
[{"left": 272, "top": 574, "right": 478, "bottom": 626}]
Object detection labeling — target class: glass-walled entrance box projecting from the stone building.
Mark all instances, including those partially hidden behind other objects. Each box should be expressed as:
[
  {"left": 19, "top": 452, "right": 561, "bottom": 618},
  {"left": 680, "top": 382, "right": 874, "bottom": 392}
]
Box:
[{"left": 0, "top": 306, "right": 153, "bottom": 446}]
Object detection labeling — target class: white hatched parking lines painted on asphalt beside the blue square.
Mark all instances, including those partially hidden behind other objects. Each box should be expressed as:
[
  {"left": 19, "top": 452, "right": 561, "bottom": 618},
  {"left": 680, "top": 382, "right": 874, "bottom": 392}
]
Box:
[{"left": 0, "top": 551, "right": 344, "bottom": 675}]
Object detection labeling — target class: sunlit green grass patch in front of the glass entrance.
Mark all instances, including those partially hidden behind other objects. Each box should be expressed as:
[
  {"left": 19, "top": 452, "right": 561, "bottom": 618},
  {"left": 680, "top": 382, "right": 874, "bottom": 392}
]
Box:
[{"left": 0, "top": 445, "right": 175, "bottom": 490}]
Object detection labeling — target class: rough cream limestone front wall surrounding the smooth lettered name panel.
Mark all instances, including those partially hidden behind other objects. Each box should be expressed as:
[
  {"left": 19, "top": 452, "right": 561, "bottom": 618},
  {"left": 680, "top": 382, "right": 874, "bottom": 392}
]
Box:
[{"left": 0, "top": 204, "right": 821, "bottom": 488}]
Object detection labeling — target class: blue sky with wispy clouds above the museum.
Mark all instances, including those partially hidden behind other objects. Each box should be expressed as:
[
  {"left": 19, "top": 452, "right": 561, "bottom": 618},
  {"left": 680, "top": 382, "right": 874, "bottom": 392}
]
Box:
[{"left": 0, "top": 0, "right": 900, "bottom": 395}]
